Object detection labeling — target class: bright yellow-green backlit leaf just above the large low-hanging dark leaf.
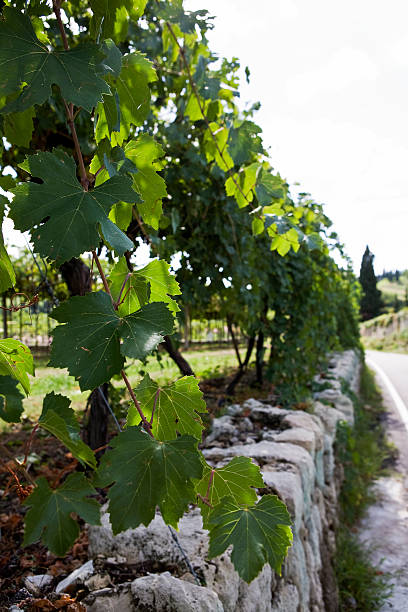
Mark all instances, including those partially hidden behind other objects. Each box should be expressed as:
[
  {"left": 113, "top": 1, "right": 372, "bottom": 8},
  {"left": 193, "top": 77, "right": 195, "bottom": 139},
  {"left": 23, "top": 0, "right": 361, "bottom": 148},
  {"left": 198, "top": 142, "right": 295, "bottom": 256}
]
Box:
[{"left": 127, "top": 374, "right": 207, "bottom": 442}]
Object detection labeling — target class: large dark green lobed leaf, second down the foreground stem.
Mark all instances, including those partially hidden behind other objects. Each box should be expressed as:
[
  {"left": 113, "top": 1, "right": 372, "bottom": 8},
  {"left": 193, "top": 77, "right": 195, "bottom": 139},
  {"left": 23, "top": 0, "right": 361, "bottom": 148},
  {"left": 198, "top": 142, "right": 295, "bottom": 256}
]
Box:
[{"left": 9, "top": 151, "right": 139, "bottom": 263}]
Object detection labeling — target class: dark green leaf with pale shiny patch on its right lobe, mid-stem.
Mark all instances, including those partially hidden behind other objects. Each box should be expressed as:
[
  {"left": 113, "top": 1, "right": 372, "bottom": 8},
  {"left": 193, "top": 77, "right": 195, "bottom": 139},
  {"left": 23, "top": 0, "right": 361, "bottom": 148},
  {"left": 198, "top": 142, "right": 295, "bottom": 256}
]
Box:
[{"left": 50, "top": 291, "right": 174, "bottom": 391}]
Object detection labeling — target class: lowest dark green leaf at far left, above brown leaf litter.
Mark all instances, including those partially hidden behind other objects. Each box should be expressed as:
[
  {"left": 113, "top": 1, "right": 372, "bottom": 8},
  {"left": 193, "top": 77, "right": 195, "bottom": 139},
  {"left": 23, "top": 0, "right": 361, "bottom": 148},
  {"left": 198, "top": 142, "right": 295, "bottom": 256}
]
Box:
[{"left": 23, "top": 473, "right": 100, "bottom": 557}]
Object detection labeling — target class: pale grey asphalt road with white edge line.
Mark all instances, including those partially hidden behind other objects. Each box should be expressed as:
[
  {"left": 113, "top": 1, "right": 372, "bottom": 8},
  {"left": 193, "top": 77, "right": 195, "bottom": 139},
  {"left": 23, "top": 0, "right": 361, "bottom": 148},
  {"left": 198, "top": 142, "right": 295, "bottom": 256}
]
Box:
[{"left": 359, "top": 351, "right": 408, "bottom": 612}]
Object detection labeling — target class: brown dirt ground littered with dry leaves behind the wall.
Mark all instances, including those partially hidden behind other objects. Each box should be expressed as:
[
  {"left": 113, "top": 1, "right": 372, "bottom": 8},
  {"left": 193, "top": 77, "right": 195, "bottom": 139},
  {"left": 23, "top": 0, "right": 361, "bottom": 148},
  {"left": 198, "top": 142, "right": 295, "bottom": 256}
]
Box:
[{"left": 0, "top": 374, "right": 275, "bottom": 612}]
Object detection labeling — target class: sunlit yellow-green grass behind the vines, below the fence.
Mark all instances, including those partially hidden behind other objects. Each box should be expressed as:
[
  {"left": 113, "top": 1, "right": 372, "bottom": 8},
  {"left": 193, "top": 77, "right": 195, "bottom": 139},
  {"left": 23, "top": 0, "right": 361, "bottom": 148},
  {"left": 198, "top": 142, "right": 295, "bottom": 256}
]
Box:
[{"left": 8, "top": 347, "right": 242, "bottom": 430}]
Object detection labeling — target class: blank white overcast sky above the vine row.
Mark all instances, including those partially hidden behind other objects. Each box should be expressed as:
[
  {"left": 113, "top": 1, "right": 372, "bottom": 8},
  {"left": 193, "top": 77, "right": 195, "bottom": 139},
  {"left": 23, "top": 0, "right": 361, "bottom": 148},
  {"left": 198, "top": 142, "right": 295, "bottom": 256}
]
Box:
[{"left": 185, "top": 0, "right": 408, "bottom": 273}]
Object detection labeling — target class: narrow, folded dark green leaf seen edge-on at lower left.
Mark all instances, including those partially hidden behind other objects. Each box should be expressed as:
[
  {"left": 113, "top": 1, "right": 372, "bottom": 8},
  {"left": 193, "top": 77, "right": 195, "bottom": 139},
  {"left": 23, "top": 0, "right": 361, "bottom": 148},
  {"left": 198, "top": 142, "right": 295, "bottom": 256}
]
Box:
[{"left": 38, "top": 392, "right": 96, "bottom": 468}]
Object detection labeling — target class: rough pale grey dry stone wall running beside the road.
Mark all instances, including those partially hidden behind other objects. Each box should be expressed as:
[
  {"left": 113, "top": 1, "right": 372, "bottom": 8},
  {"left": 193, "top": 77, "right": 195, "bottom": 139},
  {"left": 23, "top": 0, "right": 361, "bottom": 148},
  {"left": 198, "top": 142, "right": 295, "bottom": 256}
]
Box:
[{"left": 83, "top": 351, "right": 360, "bottom": 612}]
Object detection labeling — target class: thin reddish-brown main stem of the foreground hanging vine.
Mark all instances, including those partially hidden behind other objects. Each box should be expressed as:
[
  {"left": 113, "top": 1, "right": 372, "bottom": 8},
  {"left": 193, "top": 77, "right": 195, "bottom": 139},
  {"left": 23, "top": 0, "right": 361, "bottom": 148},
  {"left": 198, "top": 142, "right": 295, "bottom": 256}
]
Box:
[{"left": 53, "top": 0, "right": 154, "bottom": 438}]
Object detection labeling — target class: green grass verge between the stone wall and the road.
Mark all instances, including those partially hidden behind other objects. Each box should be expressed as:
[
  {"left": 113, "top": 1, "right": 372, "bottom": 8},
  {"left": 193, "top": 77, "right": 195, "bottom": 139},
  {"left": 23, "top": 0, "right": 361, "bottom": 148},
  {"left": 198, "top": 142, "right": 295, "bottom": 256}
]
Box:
[{"left": 335, "top": 366, "right": 393, "bottom": 612}]
